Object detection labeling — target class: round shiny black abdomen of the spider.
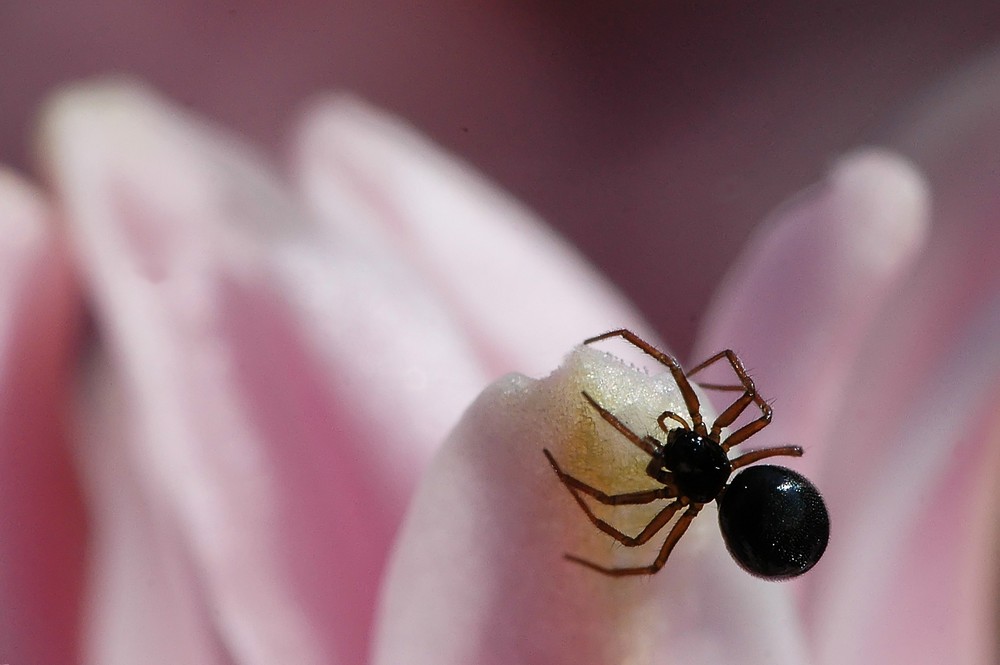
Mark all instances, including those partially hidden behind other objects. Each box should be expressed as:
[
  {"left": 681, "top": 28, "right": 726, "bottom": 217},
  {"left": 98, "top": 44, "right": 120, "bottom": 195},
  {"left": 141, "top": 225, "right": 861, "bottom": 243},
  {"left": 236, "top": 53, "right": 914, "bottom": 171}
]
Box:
[{"left": 719, "top": 464, "right": 830, "bottom": 579}]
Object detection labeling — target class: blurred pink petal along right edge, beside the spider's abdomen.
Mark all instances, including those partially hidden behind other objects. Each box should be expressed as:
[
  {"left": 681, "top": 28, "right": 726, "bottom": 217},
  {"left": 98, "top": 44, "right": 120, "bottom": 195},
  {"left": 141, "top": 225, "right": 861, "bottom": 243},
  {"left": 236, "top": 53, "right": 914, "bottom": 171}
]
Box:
[{"left": 807, "top": 258, "right": 1000, "bottom": 663}]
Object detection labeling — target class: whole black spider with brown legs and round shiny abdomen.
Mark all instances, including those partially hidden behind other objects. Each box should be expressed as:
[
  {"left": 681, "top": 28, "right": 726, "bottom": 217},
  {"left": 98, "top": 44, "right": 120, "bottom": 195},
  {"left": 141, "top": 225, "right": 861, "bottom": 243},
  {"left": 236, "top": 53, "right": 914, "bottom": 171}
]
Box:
[{"left": 544, "top": 329, "right": 830, "bottom": 580}]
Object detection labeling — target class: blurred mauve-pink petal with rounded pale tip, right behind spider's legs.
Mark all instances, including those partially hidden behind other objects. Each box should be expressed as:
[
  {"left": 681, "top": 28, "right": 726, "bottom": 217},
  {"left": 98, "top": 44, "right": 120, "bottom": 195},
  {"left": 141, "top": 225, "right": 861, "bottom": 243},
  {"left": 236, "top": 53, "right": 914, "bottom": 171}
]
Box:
[{"left": 692, "top": 150, "right": 928, "bottom": 478}]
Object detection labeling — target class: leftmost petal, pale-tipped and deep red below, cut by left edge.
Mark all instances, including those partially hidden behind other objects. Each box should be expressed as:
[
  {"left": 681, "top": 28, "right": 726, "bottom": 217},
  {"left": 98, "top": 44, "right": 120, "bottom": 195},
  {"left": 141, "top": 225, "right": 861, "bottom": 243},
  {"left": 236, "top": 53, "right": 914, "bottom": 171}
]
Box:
[{"left": 0, "top": 168, "right": 86, "bottom": 663}]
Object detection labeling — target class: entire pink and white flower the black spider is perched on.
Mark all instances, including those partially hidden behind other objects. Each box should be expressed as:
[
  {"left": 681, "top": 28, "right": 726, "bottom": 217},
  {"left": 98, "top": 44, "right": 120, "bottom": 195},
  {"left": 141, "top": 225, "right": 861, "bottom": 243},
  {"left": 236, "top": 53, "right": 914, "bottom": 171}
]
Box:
[{"left": 0, "top": 68, "right": 1000, "bottom": 665}]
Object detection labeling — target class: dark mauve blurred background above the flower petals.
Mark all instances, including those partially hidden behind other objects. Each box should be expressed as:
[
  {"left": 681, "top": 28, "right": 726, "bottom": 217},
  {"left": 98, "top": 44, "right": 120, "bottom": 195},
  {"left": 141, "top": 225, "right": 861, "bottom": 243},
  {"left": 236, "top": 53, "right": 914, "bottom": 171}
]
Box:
[{"left": 0, "top": 0, "right": 1000, "bottom": 356}]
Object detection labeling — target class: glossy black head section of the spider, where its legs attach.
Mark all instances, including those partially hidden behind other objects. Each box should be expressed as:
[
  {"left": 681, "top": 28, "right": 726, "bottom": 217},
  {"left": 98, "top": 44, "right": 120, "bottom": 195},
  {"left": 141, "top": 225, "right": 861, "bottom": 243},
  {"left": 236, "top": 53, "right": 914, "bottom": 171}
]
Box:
[{"left": 660, "top": 428, "right": 733, "bottom": 503}]
